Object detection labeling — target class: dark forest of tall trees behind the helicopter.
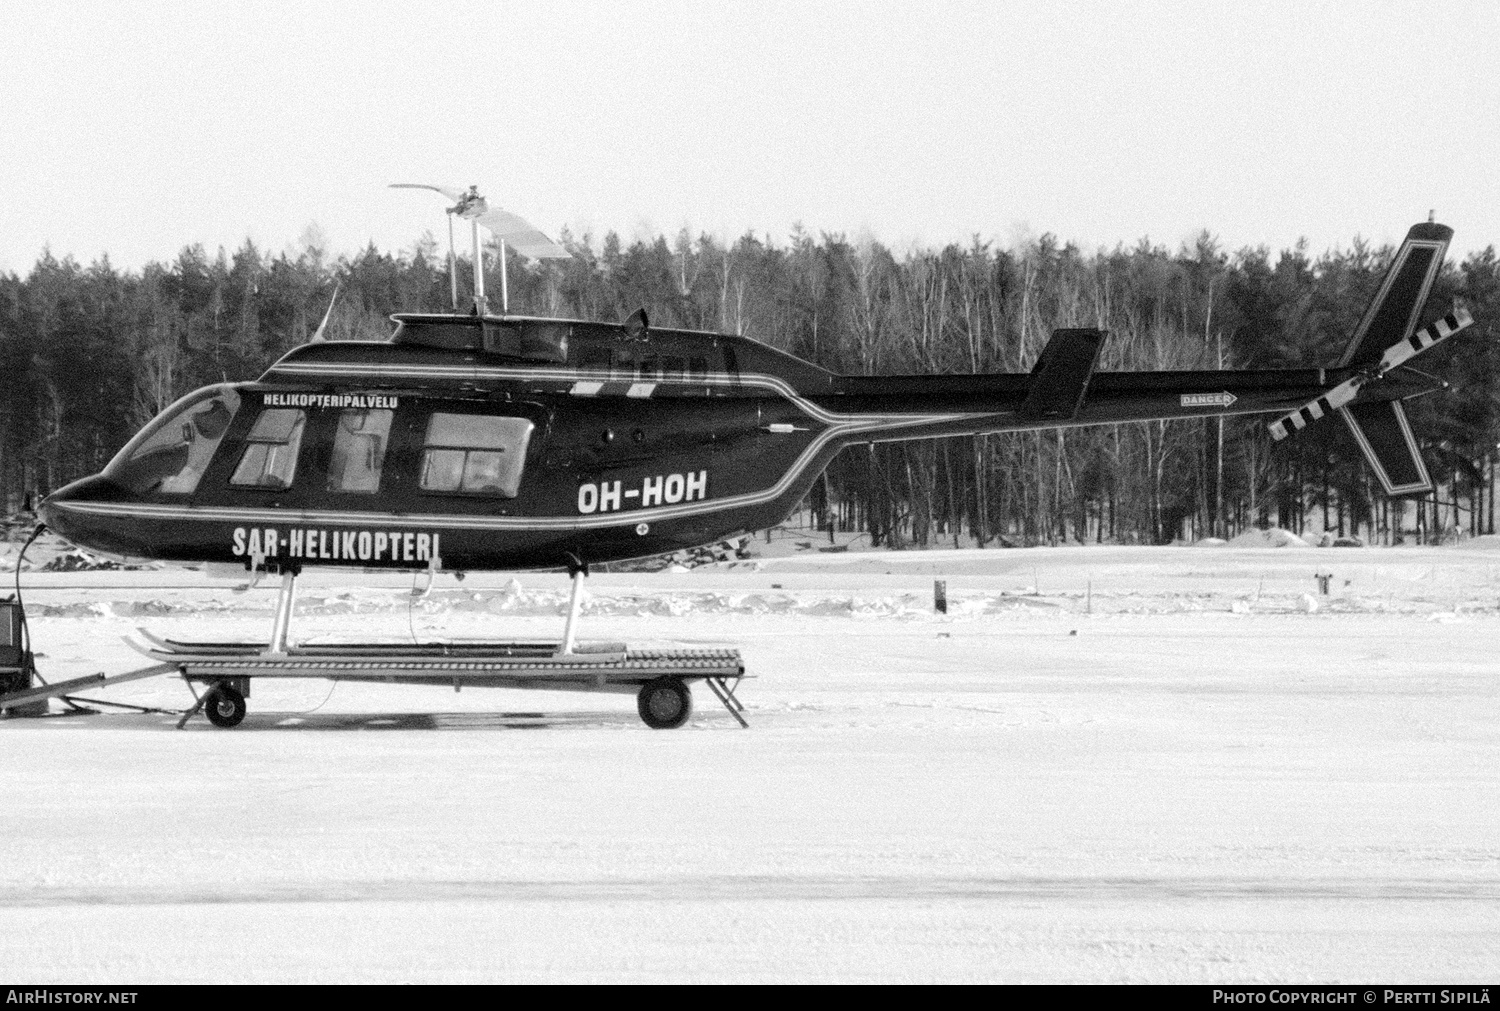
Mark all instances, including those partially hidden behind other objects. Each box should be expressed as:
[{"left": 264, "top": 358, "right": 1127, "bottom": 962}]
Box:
[{"left": 0, "top": 228, "right": 1500, "bottom": 548}]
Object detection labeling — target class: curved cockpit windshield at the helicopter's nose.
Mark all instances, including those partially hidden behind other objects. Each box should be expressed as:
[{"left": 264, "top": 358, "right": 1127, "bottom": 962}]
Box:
[{"left": 104, "top": 386, "right": 240, "bottom": 495}]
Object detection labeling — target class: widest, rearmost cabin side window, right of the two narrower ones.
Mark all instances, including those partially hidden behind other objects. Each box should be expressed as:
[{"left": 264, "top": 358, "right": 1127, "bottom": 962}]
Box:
[{"left": 420, "top": 414, "right": 533, "bottom": 498}]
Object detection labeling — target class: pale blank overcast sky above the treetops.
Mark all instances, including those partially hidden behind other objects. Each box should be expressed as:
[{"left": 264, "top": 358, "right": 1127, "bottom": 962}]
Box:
[{"left": 0, "top": 0, "right": 1500, "bottom": 273}]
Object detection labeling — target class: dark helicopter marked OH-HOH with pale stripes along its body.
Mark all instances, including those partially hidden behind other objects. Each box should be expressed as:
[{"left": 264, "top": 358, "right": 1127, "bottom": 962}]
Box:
[{"left": 20, "top": 196, "right": 1473, "bottom": 726}]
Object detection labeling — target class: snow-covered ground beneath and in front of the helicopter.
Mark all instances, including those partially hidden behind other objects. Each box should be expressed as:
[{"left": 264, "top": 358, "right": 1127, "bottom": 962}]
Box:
[{"left": 0, "top": 542, "right": 1500, "bottom": 983}]
